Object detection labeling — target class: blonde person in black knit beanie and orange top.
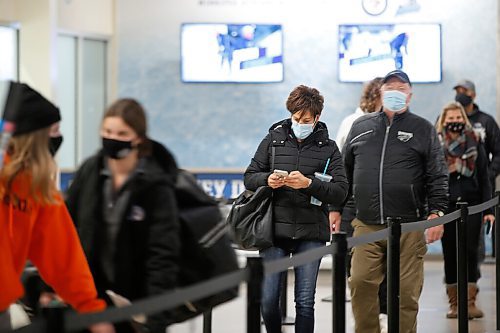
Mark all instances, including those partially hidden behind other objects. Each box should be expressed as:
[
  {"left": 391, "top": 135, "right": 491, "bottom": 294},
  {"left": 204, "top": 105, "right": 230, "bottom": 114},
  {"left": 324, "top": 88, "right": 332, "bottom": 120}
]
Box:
[{"left": 0, "top": 84, "right": 114, "bottom": 333}]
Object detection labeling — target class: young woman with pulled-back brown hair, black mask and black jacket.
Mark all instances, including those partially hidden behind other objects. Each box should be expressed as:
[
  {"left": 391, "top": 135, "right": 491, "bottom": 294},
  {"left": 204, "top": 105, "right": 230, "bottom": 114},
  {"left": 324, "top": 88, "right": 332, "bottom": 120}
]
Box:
[{"left": 66, "top": 99, "right": 180, "bottom": 333}]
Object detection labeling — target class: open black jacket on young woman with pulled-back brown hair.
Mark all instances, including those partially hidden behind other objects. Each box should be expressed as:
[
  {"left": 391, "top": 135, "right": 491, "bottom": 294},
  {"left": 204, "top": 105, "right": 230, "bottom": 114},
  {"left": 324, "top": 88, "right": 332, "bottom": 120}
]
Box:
[{"left": 66, "top": 142, "right": 181, "bottom": 332}]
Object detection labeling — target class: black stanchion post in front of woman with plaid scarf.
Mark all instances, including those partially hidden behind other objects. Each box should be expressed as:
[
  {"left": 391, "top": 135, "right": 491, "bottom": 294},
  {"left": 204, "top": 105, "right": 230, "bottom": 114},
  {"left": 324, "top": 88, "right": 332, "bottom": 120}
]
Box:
[{"left": 456, "top": 202, "right": 469, "bottom": 333}]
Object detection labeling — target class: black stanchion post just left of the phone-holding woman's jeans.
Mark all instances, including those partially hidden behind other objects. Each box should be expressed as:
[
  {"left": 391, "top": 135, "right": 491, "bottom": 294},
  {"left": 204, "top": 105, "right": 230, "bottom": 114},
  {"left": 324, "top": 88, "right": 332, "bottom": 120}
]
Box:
[{"left": 247, "top": 257, "right": 264, "bottom": 333}]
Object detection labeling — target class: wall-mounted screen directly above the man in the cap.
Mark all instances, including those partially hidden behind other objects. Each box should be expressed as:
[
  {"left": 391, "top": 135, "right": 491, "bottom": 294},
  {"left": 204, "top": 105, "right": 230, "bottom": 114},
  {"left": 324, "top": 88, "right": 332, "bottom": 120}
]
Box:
[{"left": 338, "top": 23, "right": 441, "bottom": 82}]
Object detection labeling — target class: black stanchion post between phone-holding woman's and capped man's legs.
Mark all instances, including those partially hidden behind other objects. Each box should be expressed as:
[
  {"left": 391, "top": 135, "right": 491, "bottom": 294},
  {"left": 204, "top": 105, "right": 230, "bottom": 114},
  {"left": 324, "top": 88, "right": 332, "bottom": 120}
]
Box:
[{"left": 331, "top": 232, "right": 347, "bottom": 333}]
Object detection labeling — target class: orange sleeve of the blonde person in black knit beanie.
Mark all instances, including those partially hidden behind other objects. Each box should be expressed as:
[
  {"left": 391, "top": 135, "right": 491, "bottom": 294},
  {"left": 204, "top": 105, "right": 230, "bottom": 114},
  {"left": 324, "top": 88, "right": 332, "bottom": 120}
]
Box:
[{"left": 28, "top": 193, "right": 106, "bottom": 312}]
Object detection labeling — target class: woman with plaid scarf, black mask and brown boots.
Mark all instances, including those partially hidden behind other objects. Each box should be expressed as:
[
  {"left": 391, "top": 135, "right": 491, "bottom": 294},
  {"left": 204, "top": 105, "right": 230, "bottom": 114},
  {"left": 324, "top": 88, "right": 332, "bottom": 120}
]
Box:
[{"left": 436, "top": 102, "right": 495, "bottom": 318}]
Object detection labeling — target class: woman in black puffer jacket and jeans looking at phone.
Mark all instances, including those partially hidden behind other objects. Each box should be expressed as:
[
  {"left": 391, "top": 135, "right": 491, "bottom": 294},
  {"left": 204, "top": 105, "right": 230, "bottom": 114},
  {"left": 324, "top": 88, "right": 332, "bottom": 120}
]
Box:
[{"left": 244, "top": 85, "right": 348, "bottom": 333}]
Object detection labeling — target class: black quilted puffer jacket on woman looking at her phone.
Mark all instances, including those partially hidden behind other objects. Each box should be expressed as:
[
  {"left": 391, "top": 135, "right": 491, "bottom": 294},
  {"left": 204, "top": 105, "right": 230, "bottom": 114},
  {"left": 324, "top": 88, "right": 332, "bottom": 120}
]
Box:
[{"left": 245, "top": 119, "right": 348, "bottom": 241}]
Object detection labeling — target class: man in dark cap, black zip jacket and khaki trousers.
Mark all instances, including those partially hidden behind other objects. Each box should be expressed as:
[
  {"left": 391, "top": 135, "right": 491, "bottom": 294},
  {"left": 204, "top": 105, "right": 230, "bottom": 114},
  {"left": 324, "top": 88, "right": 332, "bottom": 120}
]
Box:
[{"left": 343, "top": 70, "right": 448, "bottom": 333}]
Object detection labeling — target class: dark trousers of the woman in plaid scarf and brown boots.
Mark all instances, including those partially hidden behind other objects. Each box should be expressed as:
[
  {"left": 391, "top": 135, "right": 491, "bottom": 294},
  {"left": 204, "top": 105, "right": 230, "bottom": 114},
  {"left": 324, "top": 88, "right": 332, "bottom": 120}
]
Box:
[{"left": 441, "top": 205, "right": 482, "bottom": 284}]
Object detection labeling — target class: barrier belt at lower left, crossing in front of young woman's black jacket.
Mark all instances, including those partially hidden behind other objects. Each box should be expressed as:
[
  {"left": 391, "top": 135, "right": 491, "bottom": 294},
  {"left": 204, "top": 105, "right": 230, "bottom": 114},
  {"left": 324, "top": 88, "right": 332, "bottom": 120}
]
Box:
[{"left": 64, "top": 268, "right": 250, "bottom": 333}]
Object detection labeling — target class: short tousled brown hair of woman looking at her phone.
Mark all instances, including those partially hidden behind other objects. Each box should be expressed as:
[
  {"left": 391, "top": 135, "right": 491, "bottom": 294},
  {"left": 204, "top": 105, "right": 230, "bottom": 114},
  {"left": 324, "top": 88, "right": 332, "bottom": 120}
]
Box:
[{"left": 286, "top": 85, "right": 325, "bottom": 117}]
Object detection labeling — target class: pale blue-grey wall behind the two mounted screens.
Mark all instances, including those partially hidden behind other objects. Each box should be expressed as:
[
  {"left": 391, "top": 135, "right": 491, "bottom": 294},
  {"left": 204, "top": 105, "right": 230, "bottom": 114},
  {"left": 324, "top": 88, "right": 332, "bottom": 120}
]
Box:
[{"left": 116, "top": 0, "right": 498, "bottom": 169}]
